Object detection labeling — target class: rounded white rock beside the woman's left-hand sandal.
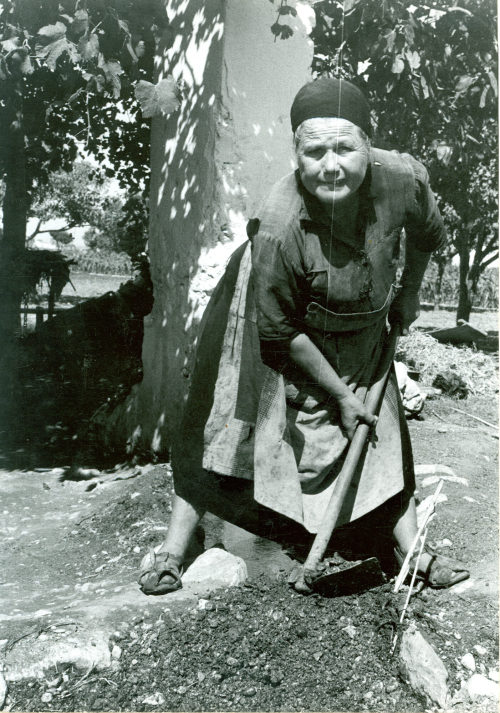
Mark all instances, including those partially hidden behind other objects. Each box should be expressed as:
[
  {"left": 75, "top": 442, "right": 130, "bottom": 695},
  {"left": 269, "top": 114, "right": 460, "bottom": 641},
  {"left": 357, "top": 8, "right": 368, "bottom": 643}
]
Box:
[{"left": 182, "top": 547, "right": 248, "bottom": 590}]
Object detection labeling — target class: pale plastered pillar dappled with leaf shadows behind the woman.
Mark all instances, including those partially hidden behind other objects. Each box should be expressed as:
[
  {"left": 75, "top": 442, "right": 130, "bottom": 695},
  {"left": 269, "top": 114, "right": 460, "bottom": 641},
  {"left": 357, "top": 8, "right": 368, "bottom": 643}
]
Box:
[{"left": 128, "top": 0, "right": 312, "bottom": 452}]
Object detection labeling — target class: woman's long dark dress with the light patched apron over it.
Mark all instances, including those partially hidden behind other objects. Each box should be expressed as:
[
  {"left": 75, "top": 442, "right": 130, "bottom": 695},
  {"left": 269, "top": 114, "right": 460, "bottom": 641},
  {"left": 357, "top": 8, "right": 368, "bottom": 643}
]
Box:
[{"left": 173, "top": 149, "right": 444, "bottom": 532}]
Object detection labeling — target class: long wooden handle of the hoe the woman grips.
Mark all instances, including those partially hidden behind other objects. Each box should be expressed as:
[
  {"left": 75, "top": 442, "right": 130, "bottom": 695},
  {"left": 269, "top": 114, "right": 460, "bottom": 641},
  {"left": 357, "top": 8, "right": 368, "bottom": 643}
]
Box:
[{"left": 303, "top": 324, "right": 401, "bottom": 579}]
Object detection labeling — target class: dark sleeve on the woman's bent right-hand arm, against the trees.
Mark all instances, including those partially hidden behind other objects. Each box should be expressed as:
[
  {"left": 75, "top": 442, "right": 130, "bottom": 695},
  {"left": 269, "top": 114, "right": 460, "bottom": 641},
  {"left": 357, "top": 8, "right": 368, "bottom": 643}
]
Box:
[{"left": 405, "top": 154, "right": 447, "bottom": 253}]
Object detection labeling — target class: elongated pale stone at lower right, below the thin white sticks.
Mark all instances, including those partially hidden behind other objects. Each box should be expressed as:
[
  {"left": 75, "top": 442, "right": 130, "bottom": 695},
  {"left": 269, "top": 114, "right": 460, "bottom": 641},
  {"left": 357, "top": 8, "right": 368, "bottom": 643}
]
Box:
[{"left": 399, "top": 626, "right": 449, "bottom": 708}]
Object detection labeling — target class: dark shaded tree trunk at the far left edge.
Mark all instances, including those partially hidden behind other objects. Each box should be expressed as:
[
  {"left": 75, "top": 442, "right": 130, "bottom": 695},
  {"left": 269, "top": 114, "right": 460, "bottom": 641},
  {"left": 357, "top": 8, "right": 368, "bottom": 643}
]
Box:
[{"left": 0, "top": 78, "right": 27, "bottom": 341}]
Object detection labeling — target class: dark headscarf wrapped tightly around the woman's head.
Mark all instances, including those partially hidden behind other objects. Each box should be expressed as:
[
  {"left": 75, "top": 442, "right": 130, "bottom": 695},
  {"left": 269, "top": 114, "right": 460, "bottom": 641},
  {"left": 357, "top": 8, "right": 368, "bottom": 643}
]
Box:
[{"left": 290, "top": 77, "right": 371, "bottom": 136}]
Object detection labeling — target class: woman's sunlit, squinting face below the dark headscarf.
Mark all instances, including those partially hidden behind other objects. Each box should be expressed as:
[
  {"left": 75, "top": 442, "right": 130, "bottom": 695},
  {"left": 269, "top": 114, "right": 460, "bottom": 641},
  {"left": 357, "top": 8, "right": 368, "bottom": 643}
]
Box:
[{"left": 296, "top": 117, "right": 368, "bottom": 205}]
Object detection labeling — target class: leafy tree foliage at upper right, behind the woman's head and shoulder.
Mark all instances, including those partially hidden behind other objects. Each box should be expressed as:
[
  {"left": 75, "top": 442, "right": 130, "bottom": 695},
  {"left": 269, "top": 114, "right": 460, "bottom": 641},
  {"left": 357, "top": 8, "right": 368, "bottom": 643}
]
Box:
[{"left": 310, "top": 0, "right": 498, "bottom": 319}]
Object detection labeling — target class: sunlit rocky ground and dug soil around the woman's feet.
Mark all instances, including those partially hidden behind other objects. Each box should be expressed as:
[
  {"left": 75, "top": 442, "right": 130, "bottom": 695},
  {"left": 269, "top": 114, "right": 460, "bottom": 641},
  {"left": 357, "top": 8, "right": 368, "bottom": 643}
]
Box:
[{"left": 0, "top": 386, "right": 498, "bottom": 712}]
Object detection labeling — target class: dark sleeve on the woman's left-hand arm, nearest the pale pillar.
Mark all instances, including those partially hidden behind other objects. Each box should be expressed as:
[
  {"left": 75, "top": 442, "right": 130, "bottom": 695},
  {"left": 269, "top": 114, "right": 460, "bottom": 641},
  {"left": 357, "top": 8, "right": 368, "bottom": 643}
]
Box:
[{"left": 251, "top": 232, "right": 305, "bottom": 371}]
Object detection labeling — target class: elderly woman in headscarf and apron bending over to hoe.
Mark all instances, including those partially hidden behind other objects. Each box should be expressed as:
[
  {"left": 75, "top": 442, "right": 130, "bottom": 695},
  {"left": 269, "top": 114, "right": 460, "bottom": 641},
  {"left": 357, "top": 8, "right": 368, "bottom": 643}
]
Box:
[{"left": 139, "top": 78, "right": 468, "bottom": 594}]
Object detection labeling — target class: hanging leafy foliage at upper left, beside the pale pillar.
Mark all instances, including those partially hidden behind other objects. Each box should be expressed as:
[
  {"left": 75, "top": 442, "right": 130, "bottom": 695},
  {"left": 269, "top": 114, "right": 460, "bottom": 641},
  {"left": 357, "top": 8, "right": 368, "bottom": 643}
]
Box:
[{"left": 0, "top": 0, "right": 167, "bottom": 200}]
